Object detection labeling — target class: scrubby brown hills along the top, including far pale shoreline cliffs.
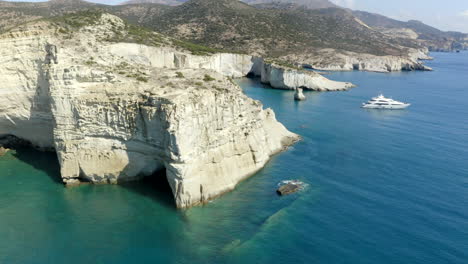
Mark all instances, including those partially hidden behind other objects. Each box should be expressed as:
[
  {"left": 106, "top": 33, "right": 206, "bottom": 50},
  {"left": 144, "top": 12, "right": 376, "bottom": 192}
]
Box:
[{"left": 0, "top": 0, "right": 434, "bottom": 71}]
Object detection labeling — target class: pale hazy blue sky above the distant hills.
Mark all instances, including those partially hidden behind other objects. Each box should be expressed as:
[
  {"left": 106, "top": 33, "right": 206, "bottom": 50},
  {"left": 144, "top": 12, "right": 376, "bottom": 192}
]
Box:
[{"left": 5, "top": 0, "right": 468, "bottom": 33}]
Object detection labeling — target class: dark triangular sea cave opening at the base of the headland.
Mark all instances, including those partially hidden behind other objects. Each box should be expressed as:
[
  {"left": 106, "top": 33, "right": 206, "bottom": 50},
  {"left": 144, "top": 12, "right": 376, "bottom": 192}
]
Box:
[{"left": 121, "top": 170, "right": 177, "bottom": 210}]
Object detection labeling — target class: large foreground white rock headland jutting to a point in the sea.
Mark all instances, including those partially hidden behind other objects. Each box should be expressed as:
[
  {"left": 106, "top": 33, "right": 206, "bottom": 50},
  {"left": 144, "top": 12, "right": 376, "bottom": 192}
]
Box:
[{"left": 50, "top": 67, "right": 297, "bottom": 207}]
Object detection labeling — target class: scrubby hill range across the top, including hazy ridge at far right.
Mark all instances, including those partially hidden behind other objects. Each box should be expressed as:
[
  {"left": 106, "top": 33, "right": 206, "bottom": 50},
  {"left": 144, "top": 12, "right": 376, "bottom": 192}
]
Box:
[{"left": 0, "top": 0, "right": 468, "bottom": 55}]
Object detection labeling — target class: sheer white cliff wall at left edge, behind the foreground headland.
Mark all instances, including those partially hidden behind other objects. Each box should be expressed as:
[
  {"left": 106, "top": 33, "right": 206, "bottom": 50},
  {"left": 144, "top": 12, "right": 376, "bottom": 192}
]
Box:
[{"left": 0, "top": 25, "right": 53, "bottom": 151}]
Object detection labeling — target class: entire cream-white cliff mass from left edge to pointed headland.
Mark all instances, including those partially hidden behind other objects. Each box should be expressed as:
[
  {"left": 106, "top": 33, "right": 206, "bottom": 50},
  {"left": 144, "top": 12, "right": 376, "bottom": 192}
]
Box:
[{"left": 0, "top": 14, "right": 298, "bottom": 208}]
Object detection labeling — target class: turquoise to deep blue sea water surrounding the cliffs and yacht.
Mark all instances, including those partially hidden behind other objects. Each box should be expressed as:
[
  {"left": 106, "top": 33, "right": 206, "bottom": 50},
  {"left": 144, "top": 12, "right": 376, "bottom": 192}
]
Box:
[{"left": 0, "top": 53, "right": 468, "bottom": 264}]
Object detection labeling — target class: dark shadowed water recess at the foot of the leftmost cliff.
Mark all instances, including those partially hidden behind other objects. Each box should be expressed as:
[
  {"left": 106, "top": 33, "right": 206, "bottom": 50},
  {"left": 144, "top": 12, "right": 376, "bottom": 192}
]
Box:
[{"left": 13, "top": 146, "right": 63, "bottom": 184}]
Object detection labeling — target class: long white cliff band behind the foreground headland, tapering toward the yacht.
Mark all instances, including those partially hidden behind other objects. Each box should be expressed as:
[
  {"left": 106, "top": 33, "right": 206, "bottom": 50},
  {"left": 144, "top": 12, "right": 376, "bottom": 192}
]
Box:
[{"left": 109, "top": 43, "right": 354, "bottom": 91}]
